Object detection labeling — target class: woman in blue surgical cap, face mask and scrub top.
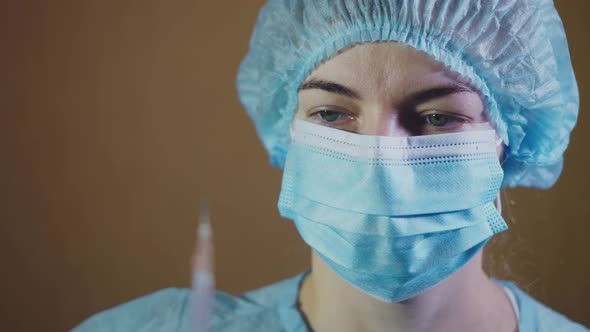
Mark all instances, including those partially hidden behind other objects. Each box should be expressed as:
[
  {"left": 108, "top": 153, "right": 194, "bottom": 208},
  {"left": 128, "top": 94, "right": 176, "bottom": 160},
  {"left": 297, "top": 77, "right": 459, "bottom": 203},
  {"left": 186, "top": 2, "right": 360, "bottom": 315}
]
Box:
[{"left": 77, "top": 0, "right": 586, "bottom": 331}]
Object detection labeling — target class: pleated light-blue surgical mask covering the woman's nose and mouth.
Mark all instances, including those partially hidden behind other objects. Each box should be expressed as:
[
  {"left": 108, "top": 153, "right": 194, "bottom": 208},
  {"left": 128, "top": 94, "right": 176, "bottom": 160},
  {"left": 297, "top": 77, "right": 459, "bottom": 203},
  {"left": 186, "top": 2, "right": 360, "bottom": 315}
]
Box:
[{"left": 279, "top": 120, "right": 507, "bottom": 302}]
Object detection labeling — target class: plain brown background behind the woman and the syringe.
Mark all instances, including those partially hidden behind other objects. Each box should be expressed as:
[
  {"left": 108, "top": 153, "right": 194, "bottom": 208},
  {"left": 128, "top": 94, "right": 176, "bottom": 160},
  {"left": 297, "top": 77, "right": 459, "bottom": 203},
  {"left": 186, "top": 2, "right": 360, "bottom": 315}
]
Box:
[{"left": 0, "top": 0, "right": 590, "bottom": 331}]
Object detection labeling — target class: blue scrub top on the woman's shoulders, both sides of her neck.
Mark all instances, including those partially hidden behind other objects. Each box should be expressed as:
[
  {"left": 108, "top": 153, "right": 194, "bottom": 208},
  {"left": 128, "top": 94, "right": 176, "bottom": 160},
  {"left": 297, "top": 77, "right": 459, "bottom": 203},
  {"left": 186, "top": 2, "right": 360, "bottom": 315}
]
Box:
[{"left": 73, "top": 273, "right": 590, "bottom": 332}]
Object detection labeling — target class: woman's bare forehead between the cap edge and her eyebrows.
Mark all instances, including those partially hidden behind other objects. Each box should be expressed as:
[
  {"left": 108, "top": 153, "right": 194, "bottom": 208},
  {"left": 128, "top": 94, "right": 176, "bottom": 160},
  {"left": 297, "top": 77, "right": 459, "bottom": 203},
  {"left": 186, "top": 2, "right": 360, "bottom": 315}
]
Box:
[{"left": 308, "top": 42, "right": 467, "bottom": 95}]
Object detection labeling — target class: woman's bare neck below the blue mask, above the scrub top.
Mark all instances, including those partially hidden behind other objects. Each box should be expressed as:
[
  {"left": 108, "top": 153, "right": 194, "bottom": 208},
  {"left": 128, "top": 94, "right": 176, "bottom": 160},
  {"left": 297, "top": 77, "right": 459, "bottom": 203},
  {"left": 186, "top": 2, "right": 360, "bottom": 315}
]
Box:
[{"left": 300, "top": 252, "right": 516, "bottom": 332}]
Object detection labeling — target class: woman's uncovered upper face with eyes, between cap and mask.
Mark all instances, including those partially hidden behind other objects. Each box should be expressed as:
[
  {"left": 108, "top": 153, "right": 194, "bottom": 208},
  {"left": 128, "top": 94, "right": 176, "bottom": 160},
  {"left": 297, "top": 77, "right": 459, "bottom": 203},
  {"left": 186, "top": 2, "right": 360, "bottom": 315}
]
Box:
[{"left": 295, "top": 42, "right": 494, "bottom": 136}]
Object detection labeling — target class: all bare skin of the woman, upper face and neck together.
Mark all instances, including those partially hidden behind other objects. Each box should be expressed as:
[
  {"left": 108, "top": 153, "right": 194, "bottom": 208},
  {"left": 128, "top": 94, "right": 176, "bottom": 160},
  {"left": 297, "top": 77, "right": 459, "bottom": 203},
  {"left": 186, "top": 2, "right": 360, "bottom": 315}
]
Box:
[{"left": 296, "top": 42, "right": 517, "bottom": 332}]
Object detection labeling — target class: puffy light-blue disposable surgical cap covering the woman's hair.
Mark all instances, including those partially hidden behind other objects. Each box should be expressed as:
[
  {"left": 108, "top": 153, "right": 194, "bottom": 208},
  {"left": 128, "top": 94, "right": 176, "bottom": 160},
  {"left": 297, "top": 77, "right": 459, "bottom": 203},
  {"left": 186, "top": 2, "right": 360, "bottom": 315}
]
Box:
[{"left": 238, "top": 0, "right": 579, "bottom": 188}]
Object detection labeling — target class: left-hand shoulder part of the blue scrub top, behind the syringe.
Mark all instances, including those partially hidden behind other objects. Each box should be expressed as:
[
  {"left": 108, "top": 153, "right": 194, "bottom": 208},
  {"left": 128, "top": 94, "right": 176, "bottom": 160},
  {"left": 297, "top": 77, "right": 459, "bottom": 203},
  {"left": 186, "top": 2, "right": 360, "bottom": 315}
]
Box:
[{"left": 73, "top": 274, "right": 307, "bottom": 332}]
